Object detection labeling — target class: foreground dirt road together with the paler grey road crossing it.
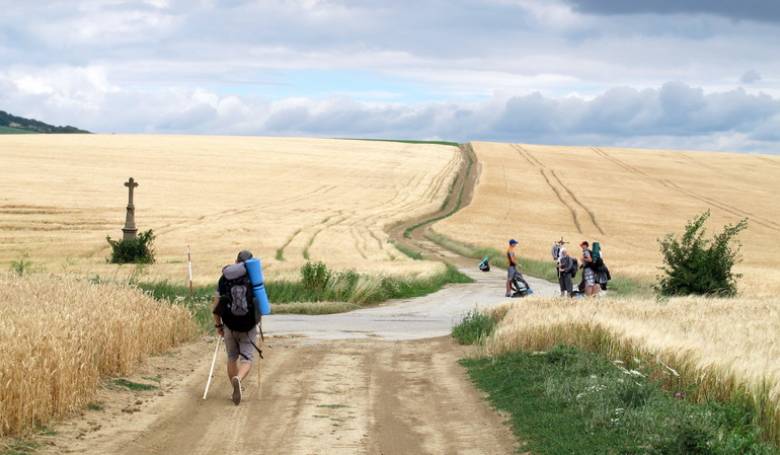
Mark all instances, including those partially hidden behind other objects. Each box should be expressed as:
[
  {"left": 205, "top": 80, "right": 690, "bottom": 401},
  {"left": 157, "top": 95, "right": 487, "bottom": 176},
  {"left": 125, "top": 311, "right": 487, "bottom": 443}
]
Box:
[{"left": 42, "top": 271, "right": 555, "bottom": 455}]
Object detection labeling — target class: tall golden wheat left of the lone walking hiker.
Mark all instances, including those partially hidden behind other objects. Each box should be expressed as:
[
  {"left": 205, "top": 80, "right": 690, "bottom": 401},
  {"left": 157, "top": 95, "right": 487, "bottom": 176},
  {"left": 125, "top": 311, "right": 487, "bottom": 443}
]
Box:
[{"left": 0, "top": 274, "right": 196, "bottom": 436}]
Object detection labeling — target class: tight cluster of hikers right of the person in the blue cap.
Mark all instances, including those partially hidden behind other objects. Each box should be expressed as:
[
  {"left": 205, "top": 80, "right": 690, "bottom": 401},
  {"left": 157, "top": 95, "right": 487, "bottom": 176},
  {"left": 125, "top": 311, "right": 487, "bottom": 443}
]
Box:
[{"left": 551, "top": 238, "right": 612, "bottom": 297}]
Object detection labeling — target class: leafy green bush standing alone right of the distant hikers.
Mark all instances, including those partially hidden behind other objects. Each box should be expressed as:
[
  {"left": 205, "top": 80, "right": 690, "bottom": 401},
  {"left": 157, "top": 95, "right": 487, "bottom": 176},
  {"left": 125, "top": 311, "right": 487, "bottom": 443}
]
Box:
[{"left": 656, "top": 210, "right": 747, "bottom": 297}]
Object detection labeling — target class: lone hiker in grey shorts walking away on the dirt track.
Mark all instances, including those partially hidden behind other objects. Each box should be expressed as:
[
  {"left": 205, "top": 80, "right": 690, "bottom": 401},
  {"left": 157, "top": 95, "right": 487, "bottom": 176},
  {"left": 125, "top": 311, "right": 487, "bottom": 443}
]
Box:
[{"left": 212, "top": 250, "right": 263, "bottom": 405}]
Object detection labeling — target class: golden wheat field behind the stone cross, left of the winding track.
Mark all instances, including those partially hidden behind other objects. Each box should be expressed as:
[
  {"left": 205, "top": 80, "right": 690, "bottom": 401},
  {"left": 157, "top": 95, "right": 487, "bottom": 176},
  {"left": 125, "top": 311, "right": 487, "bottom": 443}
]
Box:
[{"left": 0, "top": 135, "right": 462, "bottom": 283}]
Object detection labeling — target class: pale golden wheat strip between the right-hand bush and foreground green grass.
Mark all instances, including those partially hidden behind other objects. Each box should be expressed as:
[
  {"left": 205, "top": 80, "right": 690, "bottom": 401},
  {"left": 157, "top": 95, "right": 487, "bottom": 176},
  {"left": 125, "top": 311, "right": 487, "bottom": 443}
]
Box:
[{"left": 485, "top": 298, "right": 780, "bottom": 445}]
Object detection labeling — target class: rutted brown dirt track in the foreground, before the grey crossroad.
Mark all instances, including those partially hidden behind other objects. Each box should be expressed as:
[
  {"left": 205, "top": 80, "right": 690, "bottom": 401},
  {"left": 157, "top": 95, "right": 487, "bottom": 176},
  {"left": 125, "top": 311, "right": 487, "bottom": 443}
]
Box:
[{"left": 41, "top": 338, "right": 515, "bottom": 455}]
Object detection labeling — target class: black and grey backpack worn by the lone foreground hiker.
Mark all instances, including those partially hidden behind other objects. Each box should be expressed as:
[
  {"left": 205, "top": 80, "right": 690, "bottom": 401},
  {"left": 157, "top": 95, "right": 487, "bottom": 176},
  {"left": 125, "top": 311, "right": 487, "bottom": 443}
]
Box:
[{"left": 219, "top": 263, "right": 258, "bottom": 332}]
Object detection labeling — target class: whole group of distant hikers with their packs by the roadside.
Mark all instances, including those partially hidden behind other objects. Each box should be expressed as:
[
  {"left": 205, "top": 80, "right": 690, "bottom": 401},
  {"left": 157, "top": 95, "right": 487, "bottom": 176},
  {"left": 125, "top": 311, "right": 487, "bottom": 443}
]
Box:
[{"left": 500, "top": 238, "right": 612, "bottom": 297}]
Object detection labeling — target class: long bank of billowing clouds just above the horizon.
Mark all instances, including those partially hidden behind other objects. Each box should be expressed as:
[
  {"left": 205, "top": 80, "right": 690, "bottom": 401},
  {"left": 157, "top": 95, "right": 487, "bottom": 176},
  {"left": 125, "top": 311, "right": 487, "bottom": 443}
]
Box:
[{"left": 0, "top": 67, "right": 780, "bottom": 152}]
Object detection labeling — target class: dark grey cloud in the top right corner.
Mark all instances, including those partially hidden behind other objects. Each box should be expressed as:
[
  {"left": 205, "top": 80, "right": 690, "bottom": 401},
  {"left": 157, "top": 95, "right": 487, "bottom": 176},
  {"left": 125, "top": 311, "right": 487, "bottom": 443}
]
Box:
[{"left": 568, "top": 0, "right": 780, "bottom": 22}]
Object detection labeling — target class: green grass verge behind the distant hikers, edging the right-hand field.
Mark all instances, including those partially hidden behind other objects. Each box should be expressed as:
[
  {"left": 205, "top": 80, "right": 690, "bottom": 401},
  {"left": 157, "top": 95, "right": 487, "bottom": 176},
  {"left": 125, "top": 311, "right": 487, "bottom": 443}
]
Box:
[{"left": 425, "top": 230, "right": 653, "bottom": 296}]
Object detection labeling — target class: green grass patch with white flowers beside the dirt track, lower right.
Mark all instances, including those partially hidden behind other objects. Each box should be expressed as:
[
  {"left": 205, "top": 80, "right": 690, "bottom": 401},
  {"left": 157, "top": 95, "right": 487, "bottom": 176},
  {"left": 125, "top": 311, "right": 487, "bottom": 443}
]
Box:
[{"left": 461, "top": 346, "right": 778, "bottom": 454}]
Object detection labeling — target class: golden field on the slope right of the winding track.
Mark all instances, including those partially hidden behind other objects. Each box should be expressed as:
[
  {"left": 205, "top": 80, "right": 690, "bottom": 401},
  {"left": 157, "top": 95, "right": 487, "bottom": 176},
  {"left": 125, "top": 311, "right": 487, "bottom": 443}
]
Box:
[{"left": 434, "top": 142, "right": 780, "bottom": 296}]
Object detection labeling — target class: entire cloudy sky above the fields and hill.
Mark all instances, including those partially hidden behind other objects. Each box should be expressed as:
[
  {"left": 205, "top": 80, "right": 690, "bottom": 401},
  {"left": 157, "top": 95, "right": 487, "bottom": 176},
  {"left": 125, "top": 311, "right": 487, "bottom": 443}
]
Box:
[{"left": 0, "top": 0, "right": 780, "bottom": 154}]
